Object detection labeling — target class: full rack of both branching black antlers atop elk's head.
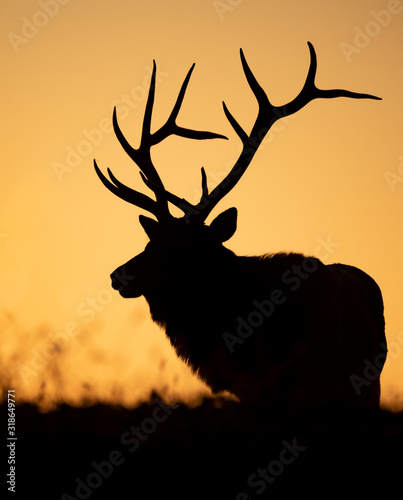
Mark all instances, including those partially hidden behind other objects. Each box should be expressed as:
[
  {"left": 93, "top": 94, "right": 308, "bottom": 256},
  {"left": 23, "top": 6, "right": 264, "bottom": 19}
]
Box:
[{"left": 94, "top": 42, "right": 380, "bottom": 223}]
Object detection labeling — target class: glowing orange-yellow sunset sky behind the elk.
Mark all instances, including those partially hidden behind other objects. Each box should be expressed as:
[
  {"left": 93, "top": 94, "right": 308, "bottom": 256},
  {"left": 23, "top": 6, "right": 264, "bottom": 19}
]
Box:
[{"left": 0, "top": 0, "right": 403, "bottom": 410}]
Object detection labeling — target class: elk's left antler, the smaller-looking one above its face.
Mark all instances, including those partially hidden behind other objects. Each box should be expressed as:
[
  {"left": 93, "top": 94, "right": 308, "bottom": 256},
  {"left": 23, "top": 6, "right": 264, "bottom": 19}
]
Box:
[{"left": 94, "top": 61, "right": 227, "bottom": 220}]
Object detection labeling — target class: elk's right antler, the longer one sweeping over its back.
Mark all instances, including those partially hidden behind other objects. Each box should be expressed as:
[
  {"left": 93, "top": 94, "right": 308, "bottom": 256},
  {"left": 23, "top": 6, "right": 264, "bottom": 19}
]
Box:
[{"left": 149, "top": 42, "right": 380, "bottom": 222}]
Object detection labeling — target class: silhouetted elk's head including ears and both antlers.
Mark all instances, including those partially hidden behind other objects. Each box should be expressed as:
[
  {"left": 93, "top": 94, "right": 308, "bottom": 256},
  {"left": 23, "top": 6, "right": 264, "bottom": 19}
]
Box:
[{"left": 94, "top": 42, "right": 379, "bottom": 297}]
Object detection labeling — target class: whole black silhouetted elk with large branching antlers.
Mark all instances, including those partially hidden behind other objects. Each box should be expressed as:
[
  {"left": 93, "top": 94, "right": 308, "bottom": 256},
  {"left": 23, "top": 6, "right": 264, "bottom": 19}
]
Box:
[{"left": 94, "top": 42, "right": 386, "bottom": 411}]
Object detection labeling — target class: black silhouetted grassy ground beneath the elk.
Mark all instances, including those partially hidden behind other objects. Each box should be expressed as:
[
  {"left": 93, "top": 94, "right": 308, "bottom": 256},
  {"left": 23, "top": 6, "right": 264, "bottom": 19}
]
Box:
[{"left": 1, "top": 395, "right": 403, "bottom": 500}]
